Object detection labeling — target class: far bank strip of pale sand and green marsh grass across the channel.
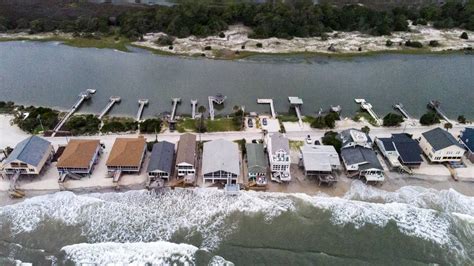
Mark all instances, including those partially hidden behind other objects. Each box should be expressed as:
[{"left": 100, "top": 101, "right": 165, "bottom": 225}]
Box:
[{"left": 0, "top": 25, "right": 474, "bottom": 60}]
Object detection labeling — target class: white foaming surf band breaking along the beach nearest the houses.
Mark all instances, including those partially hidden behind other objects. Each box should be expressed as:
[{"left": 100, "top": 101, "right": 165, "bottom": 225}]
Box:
[{"left": 0, "top": 181, "right": 474, "bottom": 264}]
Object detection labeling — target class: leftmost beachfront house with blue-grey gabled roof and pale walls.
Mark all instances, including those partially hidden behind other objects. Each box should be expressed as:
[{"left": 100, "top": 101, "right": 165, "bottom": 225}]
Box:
[{"left": 2, "top": 136, "right": 54, "bottom": 175}]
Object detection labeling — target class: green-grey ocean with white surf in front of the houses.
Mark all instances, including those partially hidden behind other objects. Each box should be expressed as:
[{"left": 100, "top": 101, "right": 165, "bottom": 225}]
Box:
[{"left": 0, "top": 181, "right": 474, "bottom": 265}]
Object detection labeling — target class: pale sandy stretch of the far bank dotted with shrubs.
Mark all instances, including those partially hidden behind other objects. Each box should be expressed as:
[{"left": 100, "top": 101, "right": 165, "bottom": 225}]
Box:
[{"left": 133, "top": 25, "right": 474, "bottom": 58}]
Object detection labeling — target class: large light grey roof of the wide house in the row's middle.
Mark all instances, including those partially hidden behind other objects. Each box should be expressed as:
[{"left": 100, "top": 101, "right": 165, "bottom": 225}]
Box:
[{"left": 202, "top": 139, "right": 240, "bottom": 175}]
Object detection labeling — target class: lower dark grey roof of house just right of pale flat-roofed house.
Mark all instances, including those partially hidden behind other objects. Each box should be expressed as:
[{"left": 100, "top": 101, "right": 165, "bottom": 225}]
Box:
[{"left": 341, "top": 146, "right": 383, "bottom": 170}]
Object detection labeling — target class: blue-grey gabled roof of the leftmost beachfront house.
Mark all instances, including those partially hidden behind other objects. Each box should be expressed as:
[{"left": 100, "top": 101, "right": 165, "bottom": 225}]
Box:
[{"left": 4, "top": 136, "right": 51, "bottom": 166}]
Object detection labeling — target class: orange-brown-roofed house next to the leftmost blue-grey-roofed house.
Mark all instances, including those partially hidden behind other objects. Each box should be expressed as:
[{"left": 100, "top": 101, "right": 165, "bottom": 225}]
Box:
[{"left": 56, "top": 139, "right": 101, "bottom": 176}]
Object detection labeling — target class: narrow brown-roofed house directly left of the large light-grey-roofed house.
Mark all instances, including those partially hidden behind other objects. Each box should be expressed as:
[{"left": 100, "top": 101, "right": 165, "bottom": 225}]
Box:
[{"left": 176, "top": 133, "right": 196, "bottom": 177}]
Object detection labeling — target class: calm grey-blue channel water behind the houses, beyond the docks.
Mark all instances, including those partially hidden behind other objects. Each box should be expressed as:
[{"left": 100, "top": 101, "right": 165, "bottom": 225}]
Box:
[{"left": 0, "top": 42, "right": 474, "bottom": 118}]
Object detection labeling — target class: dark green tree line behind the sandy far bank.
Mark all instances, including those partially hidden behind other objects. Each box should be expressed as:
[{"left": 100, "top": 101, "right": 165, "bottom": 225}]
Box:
[{"left": 0, "top": 0, "right": 474, "bottom": 40}]
